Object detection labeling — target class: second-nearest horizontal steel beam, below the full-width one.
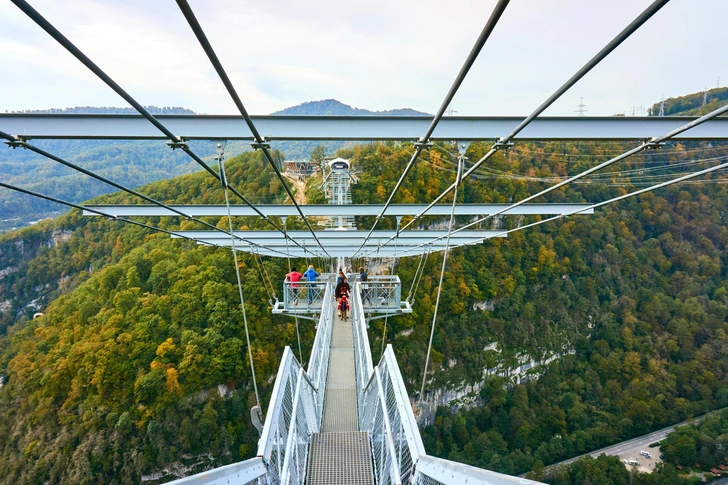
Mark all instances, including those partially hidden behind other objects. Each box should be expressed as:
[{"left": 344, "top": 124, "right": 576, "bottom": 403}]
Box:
[{"left": 83, "top": 204, "right": 594, "bottom": 217}]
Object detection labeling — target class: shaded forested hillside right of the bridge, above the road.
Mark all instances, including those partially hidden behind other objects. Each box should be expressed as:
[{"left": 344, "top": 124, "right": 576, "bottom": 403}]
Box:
[{"left": 346, "top": 131, "right": 728, "bottom": 474}]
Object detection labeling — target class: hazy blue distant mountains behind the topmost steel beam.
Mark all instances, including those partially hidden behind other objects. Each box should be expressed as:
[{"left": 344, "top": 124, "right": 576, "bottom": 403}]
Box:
[{"left": 0, "top": 99, "right": 426, "bottom": 233}]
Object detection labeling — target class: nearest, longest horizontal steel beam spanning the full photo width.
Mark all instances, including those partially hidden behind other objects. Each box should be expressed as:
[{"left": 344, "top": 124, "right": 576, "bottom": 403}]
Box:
[{"left": 5, "top": 113, "right": 728, "bottom": 141}]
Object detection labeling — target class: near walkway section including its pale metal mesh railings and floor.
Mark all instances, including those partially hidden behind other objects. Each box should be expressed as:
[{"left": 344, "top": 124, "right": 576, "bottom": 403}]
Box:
[{"left": 172, "top": 281, "right": 537, "bottom": 485}]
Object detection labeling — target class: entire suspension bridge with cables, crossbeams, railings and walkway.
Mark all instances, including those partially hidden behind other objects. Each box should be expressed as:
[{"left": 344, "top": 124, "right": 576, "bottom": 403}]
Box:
[{"left": 0, "top": 0, "right": 728, "bottom": 485}]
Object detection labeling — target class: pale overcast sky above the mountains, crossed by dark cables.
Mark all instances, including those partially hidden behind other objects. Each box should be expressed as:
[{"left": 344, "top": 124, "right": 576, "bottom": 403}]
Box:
[{"left": 0, "top": 0, "right": 728, "bottom": 115}]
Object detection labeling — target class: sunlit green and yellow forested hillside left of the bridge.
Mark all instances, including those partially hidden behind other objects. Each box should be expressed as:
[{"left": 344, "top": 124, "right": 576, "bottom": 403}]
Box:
[{"left": 0, "top": 149, "right": 314, "bottom": 484}]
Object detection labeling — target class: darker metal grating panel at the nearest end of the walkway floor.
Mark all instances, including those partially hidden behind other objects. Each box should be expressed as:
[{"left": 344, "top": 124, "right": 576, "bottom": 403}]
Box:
[{"left": 306, "top": 431, "right": 374, "bottom": 485}]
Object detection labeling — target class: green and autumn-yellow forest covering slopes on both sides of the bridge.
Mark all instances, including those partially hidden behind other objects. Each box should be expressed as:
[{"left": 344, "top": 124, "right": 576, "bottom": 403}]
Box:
[{"left": 0, "top": 90, "right": 728, "bottom": 484}]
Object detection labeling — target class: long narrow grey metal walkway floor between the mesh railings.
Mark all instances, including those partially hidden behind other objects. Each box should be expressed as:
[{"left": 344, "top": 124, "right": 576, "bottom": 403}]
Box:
[{"left": 306, "top": 311, "right": 374, "bottom": 485}]
